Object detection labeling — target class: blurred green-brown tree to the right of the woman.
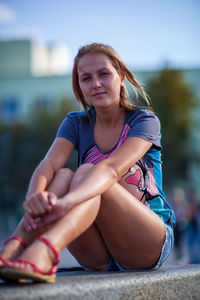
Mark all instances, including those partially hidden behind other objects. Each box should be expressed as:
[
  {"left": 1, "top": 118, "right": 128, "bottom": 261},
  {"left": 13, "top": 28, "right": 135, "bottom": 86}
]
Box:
[{"left": 147, "top": 69, "right": 195, "bottom": 183}]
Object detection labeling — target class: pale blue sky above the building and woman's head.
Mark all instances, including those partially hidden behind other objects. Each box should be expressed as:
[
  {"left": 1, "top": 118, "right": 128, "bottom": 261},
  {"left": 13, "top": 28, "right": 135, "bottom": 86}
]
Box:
[{"left": 0, "top": 0, "right": 200, "bottom": 70}]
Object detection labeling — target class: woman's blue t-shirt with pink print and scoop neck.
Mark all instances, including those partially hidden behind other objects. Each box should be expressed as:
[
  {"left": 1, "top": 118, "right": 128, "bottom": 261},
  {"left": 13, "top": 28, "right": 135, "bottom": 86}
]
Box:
[{"left": 56, "top": 109, "right": 175, "bottom": 223}]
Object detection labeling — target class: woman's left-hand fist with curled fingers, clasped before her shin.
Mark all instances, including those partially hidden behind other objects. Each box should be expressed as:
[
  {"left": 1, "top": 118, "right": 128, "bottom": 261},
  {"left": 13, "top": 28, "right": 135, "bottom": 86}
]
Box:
[{"left": 23, "top": 191, "right": 57, "bottom": 218}]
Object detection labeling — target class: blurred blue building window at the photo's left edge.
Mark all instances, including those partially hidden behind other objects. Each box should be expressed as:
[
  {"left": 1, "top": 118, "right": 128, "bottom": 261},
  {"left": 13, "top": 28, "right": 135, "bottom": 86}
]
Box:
[{"left": 0, "top": 97, "right": 20, "bottom": 123}]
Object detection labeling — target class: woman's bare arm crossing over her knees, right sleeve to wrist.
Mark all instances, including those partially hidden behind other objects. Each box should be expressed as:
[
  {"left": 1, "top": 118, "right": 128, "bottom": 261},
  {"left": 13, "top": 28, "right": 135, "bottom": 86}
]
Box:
[{"left": 61, "top": 137, "right": 152, "bottom": 210}]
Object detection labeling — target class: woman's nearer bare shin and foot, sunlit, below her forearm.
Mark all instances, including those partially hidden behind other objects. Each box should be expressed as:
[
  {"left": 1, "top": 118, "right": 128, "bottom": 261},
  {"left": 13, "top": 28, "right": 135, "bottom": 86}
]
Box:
[{"left": 7, "top": 184, "right": 100, "bottom": 272}]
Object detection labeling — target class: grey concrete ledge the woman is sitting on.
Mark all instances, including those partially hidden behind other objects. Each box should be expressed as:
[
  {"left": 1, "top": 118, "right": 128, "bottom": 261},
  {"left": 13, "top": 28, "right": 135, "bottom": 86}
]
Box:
[{"left": 0, "top": 265, "right": 200, "bottom": 300}]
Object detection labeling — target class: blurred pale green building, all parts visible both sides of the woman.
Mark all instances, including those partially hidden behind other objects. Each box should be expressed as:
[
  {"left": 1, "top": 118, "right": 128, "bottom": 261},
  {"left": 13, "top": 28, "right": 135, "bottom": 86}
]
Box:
[{"left": 0, "top": 40, "right": 200, "bottom": 191}]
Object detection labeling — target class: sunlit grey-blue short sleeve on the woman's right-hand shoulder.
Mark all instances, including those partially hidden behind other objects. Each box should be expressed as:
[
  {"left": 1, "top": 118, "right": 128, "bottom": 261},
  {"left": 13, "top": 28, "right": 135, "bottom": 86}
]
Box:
[{"left": 127, "top": 110, "right": 162, "bottom": 150}]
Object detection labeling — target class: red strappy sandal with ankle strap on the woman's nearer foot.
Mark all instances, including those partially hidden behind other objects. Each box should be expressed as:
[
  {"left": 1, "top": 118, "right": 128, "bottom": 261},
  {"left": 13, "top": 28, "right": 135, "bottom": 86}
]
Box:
[{"left": 1, "top": 236, "right": 60, "bottom": 283}]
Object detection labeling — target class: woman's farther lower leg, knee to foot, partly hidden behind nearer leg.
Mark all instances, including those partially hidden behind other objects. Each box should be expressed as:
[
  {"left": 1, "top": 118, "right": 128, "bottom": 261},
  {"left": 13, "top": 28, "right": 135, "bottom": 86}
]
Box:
[{"left": 0, "top": 169, "right": 74, "bottom": 266}]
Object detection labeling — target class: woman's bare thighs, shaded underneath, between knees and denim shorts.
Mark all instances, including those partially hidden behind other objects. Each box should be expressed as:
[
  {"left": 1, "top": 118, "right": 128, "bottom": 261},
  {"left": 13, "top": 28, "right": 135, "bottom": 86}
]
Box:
[{"left": 68, "top": 164, "right": 165, "bottom": 269}]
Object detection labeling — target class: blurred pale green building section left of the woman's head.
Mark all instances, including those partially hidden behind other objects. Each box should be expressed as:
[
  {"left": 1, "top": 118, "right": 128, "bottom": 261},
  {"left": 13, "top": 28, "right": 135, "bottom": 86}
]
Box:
[{"left": 0, "top": 40, "right": 73, "bottom": 123}]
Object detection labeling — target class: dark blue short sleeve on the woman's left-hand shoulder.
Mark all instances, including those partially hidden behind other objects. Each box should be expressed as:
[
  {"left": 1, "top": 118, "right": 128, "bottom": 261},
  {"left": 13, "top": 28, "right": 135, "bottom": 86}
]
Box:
[{"left": 56, "top": 112, "right": 78, "bottom": 148}]
